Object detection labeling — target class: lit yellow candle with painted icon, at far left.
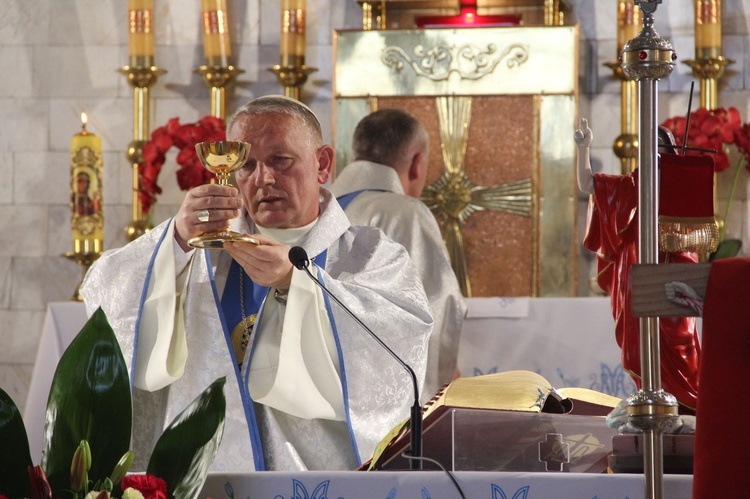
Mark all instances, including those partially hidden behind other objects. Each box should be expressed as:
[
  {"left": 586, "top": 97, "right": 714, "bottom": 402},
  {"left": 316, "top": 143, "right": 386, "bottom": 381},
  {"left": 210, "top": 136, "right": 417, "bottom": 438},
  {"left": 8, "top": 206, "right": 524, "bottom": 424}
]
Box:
[{"left": 70, "top": 113, "right": 104, "bottom": 254}]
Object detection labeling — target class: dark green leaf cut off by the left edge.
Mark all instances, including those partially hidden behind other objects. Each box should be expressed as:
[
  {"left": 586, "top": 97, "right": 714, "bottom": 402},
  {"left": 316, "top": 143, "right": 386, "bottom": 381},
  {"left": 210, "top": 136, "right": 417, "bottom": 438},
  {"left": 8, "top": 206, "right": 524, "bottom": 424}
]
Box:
[{"left": 0, "top": 388, "right": 33, "bottom": 497}]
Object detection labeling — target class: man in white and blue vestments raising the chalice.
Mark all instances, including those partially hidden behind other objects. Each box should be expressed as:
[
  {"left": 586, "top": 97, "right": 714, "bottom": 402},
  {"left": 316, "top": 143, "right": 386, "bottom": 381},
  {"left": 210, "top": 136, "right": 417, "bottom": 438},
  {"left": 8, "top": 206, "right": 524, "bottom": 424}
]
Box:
[{"left": 81, "top": 96, "right": 432, "bottom": 471}]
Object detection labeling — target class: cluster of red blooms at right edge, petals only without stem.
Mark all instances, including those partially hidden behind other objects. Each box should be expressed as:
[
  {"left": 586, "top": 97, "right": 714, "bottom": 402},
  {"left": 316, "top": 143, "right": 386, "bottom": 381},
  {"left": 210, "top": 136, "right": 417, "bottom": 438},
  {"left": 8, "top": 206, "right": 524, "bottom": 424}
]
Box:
[{"left": 662, "top": 107, "right": 750, "bottom": 172}]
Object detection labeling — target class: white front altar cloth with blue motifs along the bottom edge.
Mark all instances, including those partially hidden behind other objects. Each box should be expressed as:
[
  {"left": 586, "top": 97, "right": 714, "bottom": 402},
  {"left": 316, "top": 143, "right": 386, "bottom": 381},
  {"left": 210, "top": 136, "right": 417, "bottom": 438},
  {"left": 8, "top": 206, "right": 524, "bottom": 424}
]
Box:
[{"left": 200, "top": 471, "right": 693, "bottom": 499}]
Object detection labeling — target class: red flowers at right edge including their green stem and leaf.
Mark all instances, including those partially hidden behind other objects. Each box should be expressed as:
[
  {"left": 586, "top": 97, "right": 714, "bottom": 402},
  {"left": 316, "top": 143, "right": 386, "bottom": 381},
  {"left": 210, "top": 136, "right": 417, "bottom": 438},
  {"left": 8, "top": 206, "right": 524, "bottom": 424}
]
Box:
[{"left": 662, "top": 107, "right": 750, "bottom": 260}]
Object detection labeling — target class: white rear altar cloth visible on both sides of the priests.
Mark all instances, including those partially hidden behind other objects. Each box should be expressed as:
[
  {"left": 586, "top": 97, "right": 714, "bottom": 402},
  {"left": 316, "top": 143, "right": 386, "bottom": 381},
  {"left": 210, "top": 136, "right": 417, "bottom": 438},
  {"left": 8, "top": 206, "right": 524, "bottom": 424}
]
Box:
[{"left": 24, "top": 298, "right": 635, "bottom": 464}]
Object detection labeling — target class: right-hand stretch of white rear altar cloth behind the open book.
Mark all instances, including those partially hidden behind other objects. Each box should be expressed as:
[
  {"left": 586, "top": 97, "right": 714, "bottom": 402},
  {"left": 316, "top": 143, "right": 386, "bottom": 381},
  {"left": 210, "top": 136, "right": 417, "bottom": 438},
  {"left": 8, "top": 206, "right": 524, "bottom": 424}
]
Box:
[{"left": 458, "top": 297, "right": 636, "bottom": 398}]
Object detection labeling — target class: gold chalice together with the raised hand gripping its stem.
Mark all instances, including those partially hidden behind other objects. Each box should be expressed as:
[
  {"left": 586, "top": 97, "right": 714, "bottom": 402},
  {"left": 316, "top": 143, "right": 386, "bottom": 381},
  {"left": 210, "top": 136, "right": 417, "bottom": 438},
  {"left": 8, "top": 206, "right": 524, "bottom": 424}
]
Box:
[{"left": 181, "top": 141, "right": 258, "bottom": 249}]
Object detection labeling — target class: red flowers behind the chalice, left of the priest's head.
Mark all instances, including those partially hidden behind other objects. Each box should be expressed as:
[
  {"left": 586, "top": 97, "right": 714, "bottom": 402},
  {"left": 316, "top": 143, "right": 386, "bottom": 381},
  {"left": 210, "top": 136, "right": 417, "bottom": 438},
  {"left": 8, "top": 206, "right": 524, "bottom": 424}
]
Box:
[{"left": 138, "top": 116, "right": 226, "bottom": 215}]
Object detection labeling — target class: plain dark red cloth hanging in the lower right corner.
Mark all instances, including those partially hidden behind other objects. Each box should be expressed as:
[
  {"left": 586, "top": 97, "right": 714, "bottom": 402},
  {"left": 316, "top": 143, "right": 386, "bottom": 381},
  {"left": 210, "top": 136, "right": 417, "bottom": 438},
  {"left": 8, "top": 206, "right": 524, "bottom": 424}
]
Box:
[{"left": 693, "top": 258, "right": 750, "bottom": 499}]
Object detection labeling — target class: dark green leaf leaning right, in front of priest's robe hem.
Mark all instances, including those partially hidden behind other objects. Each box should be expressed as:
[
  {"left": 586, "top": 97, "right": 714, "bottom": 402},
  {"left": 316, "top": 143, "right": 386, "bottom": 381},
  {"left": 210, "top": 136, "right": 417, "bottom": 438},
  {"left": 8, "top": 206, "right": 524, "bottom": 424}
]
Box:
[{"left": 147, "top": 377, "right": 227, "bottom": 498}]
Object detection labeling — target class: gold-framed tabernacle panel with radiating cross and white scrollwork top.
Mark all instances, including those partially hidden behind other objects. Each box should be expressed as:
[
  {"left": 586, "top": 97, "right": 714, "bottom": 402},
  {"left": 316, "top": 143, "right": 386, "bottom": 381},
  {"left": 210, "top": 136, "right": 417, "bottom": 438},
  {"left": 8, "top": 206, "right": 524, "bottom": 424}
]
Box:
[{"left": 334, "top": 26, "right": 578, "bottom": 296}]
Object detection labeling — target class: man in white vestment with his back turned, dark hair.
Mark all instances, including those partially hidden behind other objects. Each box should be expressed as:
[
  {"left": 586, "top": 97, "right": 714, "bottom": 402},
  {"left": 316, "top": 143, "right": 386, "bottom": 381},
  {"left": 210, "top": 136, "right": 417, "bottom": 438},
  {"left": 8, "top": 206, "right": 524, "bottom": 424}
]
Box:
[{"left": 331, "top": 109, "right": 466, "bottom": 397}]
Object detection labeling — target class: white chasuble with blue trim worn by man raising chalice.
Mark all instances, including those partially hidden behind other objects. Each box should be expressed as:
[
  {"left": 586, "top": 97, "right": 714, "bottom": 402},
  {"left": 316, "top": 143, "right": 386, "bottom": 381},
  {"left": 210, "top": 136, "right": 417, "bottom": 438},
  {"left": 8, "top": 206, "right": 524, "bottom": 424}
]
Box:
[{"left": 81, "top": 188, "right": 432, "bottom": 472}]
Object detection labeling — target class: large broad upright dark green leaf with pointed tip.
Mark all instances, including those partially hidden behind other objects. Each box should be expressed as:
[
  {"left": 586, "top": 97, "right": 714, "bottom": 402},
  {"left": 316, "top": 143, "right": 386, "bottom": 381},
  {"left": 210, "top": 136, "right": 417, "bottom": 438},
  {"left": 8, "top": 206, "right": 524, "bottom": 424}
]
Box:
[{"left": 42, "top": 308, "right": 133, "bottom": 491}]
